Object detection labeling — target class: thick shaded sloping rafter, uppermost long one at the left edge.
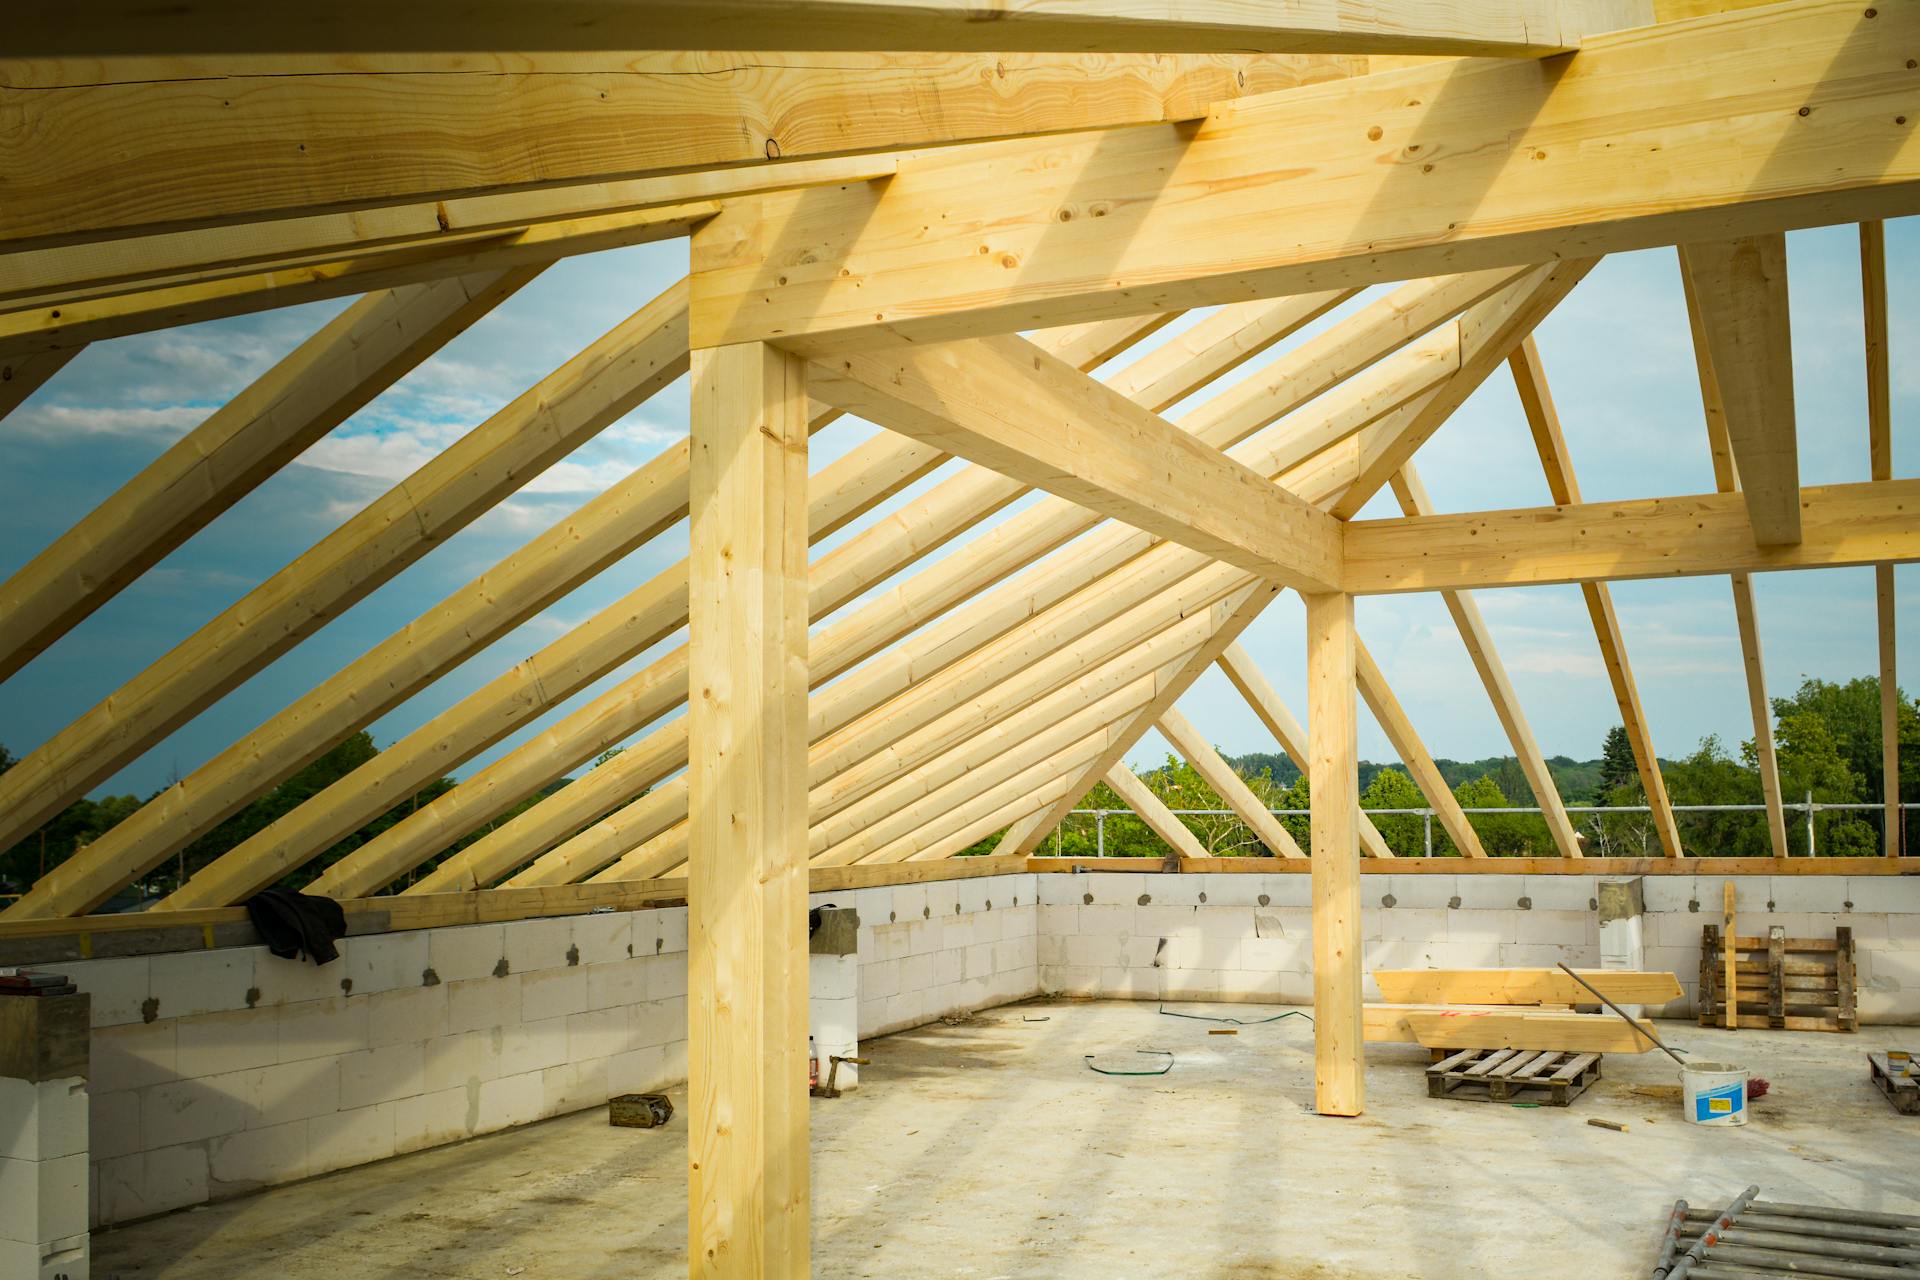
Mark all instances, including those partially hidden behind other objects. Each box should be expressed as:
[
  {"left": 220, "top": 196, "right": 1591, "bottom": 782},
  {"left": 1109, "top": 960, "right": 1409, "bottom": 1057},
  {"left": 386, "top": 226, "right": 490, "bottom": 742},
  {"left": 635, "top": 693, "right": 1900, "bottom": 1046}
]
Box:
[{"left": 0, "top": 267, "right": 540, "bottom": 679}]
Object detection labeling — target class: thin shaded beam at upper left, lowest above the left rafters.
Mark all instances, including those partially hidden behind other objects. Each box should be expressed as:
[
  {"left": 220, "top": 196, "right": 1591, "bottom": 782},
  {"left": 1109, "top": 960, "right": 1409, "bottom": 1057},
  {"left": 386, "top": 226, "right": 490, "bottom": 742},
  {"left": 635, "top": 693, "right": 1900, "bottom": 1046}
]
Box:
[{"left": 0, "top": 201, "right": 720, "bottom": 355}]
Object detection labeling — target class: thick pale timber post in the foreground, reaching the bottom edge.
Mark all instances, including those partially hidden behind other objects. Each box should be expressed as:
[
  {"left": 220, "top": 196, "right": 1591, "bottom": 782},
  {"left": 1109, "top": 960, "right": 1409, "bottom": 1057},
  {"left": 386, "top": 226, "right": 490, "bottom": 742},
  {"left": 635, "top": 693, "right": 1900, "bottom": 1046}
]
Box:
[{"left": 687, "top": 344, "right": 808, "bottom": 1280}]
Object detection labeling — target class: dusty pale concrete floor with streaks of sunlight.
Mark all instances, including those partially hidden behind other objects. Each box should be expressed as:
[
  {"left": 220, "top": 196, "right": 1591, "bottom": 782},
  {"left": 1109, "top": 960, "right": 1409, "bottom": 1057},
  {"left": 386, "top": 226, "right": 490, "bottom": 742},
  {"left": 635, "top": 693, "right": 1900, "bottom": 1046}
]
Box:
[{"left": 94, "top": 1002, "right": 1920, "bottom": 1280}]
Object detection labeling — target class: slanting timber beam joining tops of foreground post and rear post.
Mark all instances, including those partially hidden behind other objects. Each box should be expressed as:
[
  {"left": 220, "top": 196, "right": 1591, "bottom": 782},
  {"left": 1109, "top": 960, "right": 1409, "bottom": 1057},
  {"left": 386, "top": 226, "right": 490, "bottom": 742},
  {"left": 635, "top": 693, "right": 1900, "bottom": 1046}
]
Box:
[{"left": 814, "top": 336, "right": 1340, "bottom": 591}]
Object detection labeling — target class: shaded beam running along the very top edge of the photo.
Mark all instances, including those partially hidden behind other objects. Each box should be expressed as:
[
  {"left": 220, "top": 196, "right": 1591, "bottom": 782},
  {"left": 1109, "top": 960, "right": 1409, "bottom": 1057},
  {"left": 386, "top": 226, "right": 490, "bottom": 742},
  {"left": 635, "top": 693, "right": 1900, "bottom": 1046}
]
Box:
[{"left": 10, "top": 0, "right": 1653, "bottom": 58}]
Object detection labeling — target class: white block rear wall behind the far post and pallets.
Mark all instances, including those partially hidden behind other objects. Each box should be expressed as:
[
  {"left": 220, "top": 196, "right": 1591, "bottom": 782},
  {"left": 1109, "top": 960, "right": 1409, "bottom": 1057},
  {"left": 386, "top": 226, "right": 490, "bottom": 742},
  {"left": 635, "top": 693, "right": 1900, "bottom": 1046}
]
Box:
[{"left": 1037, "top": 871, "right": 1920, "bottom": 1025}]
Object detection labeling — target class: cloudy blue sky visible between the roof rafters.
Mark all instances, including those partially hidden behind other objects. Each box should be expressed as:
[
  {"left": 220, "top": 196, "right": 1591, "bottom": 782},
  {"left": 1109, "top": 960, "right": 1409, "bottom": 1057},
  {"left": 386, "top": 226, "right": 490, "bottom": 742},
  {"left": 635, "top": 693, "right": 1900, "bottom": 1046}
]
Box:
[{"left": 0, "top": 219, "right": 1920, "bottom": 794}]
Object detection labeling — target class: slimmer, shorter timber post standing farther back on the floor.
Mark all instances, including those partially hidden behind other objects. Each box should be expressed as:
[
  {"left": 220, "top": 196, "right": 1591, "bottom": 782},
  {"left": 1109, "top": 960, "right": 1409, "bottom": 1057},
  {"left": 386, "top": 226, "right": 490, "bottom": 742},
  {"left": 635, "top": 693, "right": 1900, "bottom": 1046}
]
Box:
[{"left": 1306, "top": 595, "right": 1367, "bottom": 1115}]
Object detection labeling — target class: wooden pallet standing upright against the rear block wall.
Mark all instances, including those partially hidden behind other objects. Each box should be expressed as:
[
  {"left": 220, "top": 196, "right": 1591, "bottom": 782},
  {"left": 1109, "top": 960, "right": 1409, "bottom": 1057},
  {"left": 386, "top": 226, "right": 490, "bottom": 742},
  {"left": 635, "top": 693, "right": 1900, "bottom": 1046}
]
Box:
[{"left": 1699, "top": 925, "right": 1860, "bottom": 1032}]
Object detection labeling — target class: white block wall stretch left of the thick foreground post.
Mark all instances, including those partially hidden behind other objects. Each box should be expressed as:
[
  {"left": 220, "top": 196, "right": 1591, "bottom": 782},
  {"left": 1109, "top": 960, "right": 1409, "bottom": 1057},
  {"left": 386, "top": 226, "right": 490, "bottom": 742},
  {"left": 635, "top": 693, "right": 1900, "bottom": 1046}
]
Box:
[{"left": 60, "top": 908, "right": 687, "bottom": 1228}]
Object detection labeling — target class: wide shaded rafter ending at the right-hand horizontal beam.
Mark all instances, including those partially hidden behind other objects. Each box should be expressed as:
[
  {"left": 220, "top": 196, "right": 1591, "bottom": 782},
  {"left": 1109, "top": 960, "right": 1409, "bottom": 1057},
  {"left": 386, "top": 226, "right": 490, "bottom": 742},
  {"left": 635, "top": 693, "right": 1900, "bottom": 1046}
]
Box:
[{"left": 1681, "top": 232, "right": 1799, "bottom": 547}]
